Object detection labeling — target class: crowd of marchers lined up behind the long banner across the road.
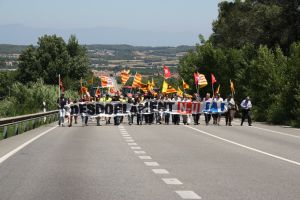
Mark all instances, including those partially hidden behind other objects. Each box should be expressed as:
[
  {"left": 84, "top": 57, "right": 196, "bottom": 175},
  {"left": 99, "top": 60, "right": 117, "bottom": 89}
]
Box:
[{"left": 57, "top": 93, "right": 252, "bottom": 127}]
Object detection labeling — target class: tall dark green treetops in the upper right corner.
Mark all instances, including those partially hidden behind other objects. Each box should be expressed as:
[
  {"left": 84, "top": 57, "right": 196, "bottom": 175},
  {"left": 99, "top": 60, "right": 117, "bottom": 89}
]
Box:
[{"left": 210, "top": 0, "right": 300, "bottom": 52}]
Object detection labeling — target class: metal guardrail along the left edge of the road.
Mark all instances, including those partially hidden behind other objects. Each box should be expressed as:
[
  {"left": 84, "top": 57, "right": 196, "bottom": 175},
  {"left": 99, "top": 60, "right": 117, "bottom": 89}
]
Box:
[{"left": 0, "top": 110, "right": 58, "bottom": 140}]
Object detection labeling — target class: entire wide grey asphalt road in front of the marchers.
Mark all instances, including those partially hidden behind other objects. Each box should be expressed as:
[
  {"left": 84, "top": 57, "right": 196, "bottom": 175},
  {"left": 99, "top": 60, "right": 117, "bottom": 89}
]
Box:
[{"left": 0, "top": 121, "right": 300, "bottom": 200}]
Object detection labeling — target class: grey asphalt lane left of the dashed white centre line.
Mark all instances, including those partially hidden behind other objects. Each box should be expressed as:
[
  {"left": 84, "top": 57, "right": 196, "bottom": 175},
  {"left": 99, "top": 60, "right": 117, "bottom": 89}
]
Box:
[{"left": 0, "top": 123, "right": 179, "bottom": 200}]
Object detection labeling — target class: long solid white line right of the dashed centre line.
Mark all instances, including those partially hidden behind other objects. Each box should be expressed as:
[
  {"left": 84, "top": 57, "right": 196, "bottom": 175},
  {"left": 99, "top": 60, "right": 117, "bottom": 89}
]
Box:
[{"left": 185, "top": 126, "right": 300, "bottom": 166}]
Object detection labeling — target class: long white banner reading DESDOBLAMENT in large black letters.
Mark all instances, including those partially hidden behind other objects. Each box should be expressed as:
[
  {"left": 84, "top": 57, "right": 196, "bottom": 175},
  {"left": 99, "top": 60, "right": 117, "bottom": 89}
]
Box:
[{"left": 70, "top": 101, "right": 227, "bottom": 117}]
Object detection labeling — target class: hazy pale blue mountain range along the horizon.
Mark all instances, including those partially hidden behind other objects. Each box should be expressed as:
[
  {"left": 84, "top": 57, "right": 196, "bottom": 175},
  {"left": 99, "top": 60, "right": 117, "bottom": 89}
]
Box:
[{"left": 0, "top": 24, "right": 202, "bottom": 46}]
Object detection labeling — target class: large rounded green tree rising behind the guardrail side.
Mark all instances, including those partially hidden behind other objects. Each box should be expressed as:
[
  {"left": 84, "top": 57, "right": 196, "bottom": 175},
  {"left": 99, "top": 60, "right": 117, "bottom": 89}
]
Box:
[{"left": 17, "top": 35, "right": 89, "bottom": 84}]
